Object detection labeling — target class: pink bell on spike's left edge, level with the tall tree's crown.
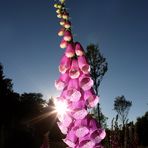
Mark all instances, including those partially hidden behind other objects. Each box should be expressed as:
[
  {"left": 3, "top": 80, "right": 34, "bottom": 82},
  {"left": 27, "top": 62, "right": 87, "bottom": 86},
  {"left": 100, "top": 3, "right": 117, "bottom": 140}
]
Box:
[{"left": 59, "top": 55, "right": 71, "bottom": 74}]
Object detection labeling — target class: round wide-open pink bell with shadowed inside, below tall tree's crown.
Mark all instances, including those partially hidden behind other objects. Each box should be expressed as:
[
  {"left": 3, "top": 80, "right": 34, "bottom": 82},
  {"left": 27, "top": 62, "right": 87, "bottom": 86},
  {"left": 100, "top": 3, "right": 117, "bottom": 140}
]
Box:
[{"left": 79, "top": 75, "right": 93, "bottom": 91}]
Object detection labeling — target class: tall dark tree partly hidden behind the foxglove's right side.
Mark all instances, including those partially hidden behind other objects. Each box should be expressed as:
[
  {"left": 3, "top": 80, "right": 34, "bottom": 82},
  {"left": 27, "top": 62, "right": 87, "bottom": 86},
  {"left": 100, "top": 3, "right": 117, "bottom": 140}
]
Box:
[{"left": 86, "top": 44, "right": 108, "bottom": 123}]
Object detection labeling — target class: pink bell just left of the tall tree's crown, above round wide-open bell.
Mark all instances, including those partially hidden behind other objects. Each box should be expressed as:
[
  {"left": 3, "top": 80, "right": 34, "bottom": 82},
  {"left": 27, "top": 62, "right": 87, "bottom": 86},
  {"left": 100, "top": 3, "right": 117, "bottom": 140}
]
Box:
[{"left": 78, "top": 56, "right": 90, "bottom": 74}]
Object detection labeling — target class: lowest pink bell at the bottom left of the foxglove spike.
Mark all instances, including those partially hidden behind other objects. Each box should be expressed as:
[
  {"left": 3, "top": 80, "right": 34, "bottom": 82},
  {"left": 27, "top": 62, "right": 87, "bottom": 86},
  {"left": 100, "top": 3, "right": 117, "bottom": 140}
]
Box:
[{"left": 63, "top": 129, "right": 78, "bottom": 148}]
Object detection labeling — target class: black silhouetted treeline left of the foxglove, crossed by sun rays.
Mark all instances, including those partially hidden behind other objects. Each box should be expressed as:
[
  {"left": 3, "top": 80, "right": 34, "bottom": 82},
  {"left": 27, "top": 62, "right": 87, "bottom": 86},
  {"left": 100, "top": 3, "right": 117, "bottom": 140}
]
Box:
[{"left": 0, "top": 64, "right": 66, "bottom": 148}]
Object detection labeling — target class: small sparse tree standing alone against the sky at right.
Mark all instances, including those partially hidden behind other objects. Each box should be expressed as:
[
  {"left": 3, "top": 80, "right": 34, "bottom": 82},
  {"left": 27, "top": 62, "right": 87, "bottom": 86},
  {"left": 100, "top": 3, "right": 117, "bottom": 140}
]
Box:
[{"left": 114, "top": 95, "right": 132, "bottom": 127}]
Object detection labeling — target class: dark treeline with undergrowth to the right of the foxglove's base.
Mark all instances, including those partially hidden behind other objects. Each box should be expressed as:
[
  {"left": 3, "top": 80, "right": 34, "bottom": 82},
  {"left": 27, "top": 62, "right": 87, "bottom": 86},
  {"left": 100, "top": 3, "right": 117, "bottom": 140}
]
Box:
[{"left": 104, "top": 112, "right": 148, "bottom": 148}]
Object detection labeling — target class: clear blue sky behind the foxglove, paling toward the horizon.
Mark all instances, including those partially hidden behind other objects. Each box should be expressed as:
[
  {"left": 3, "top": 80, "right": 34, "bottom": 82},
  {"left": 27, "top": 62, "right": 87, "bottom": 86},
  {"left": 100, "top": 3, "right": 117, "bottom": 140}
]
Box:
[{"left": 0, "top": 0, "right": 148, "bottom": 124}]
